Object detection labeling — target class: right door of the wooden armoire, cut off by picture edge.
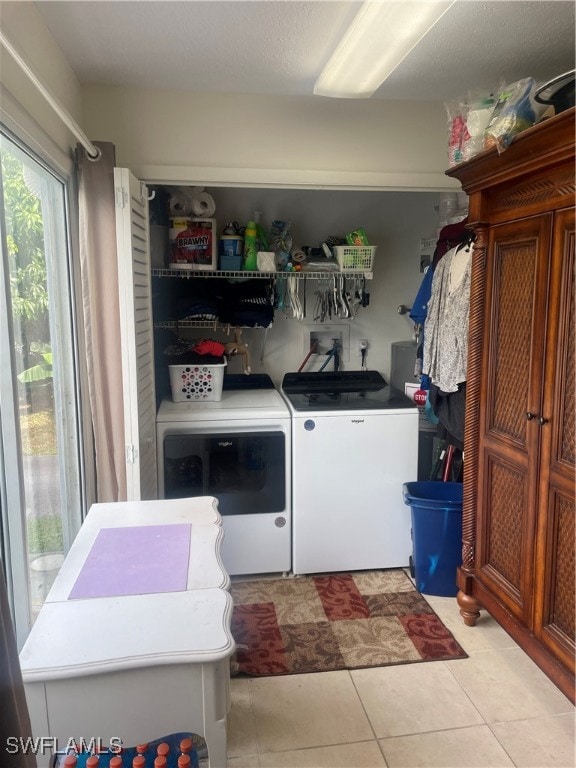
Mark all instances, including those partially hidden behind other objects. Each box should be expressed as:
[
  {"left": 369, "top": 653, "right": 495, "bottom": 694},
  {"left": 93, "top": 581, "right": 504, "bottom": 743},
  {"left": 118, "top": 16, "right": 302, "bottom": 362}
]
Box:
[{"left": 534, "top": 209, "right": 576, "bottom": 670}]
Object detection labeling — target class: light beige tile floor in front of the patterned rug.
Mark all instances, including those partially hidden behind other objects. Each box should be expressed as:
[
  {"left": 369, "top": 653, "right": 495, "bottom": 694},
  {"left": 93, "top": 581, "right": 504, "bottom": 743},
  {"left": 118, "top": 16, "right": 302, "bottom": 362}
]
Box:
[{"left": 228, "top": 584, "right": 576, "bottom": 768}]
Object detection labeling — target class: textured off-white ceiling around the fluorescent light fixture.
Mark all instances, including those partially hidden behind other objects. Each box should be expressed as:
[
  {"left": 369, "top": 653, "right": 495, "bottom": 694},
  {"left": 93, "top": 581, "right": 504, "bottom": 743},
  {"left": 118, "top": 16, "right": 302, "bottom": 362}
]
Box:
[{"left": 36, "top": 0, "right": 575, "bottom": 102}]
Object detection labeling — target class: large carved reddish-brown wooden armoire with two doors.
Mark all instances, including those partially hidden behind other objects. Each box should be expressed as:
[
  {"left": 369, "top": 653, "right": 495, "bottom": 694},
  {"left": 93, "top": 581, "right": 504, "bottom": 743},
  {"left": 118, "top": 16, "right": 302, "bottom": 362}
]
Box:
[{"left": 447, "top": 109, "right": 576, "bottom": 702}]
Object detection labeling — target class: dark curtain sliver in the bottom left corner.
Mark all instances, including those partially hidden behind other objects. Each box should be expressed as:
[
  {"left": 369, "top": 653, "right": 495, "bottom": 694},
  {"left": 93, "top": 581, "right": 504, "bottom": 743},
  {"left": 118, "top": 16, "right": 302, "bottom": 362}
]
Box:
[{"left": 0, "top": 568, "right": 36, "bottom": 768}]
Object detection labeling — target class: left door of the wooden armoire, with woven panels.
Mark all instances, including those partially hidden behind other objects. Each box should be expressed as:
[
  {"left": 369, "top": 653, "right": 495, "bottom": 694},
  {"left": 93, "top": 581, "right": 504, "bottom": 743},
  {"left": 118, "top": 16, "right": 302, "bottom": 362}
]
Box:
[{"left": 477, "top": 214, "right": 552, "bottom": 621}]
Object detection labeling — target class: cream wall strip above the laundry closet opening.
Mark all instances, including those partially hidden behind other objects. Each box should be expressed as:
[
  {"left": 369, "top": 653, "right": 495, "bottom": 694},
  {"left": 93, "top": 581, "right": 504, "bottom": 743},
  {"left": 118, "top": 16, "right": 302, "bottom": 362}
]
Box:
[{"left": 84, "top": 87, "right": 457, "bottom": 190}]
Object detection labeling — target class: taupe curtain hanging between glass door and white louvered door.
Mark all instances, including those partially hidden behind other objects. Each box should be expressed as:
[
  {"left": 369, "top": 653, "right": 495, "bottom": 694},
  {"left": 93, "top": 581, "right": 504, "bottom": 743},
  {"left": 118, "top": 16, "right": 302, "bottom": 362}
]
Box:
[{"left": 77, "top": 142, "right": 126, "bottom": 502}]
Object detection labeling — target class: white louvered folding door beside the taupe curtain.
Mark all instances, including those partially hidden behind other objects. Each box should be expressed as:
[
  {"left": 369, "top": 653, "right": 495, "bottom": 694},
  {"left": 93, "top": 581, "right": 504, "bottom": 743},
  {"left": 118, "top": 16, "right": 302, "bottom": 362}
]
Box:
[{"left": 114, "top": 168, "right": 158, "bottom": 501}]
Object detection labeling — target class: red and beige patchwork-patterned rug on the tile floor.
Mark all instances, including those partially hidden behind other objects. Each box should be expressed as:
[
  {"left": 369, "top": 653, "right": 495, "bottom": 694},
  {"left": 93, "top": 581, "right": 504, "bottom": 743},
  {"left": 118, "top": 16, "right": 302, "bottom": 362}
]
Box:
[{"left": 231, "top": 570, "right": 467, "bottom": 676}]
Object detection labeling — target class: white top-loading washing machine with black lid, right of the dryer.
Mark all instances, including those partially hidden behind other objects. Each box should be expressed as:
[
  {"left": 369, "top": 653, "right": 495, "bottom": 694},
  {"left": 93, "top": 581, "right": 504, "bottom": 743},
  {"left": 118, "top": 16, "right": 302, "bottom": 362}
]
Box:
[{"left": 282, "top": 371, "right": 418, "bottom": 574}]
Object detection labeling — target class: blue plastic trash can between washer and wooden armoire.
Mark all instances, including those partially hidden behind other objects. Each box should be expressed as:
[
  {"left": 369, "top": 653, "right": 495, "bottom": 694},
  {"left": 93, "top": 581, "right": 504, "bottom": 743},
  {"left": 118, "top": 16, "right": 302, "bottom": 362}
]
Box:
[{"left": 402, "top": 480, "right": 462, "bottom": 597}]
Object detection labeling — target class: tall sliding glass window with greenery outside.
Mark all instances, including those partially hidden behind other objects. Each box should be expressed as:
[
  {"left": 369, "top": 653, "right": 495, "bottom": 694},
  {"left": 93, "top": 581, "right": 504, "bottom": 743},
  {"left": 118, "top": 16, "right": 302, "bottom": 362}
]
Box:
[{"left": 0, "top": 132, "right": 83, "bottom": 646}]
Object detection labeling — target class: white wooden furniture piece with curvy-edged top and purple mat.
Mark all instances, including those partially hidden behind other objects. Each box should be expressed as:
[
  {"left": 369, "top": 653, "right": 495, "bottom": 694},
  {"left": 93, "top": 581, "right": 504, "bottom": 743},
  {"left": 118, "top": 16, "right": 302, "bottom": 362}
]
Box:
[{"left": 20, "top": 497, "right": 235, "bottom": 768}]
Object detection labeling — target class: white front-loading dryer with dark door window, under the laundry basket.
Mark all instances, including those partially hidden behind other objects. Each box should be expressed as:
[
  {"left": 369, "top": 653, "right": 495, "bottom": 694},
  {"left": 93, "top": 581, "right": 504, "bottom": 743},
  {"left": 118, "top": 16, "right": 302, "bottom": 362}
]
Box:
[{"left": 156, "top": 374, "right": 292, "bottom": 576}]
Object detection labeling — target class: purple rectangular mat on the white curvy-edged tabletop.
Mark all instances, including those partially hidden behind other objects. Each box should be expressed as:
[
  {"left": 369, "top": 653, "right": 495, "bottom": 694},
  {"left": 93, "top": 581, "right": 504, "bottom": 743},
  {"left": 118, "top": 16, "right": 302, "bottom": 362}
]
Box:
[{"left": 68, "top": 523, "right": 192, "bottom": 600}]
